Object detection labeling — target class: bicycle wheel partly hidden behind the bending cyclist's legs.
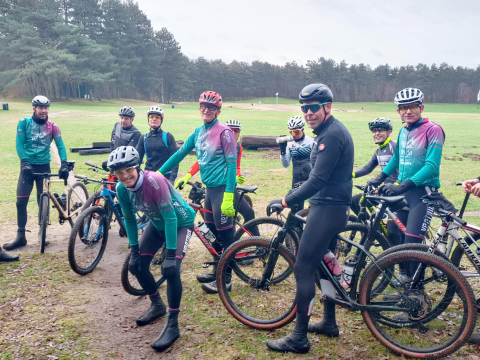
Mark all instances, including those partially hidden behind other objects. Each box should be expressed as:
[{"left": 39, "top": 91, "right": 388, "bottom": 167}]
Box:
[{"left": 121, "top": 244, "right": 165, "bottom": 296}]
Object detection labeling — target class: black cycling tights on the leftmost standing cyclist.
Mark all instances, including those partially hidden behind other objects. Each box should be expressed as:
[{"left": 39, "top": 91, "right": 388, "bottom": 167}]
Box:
[{"left": 17, "top": 164, "right": 50, "bottom": 231}]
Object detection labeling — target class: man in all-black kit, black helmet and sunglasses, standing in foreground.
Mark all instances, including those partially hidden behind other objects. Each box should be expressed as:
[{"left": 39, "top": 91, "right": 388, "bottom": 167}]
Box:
[{"left": 267, "top": 84, "right": 353, "bottom": 353}]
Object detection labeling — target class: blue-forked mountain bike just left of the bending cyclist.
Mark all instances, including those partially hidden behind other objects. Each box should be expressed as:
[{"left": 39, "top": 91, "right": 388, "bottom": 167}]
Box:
[{"left": 68, "top": 175, "right": 148, "bottom": 275}]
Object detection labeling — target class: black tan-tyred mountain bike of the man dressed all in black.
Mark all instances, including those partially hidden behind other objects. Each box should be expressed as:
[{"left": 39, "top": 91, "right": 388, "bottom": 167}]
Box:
[{"left": 217, "top": 196, "right": 477, "bottom": 358}]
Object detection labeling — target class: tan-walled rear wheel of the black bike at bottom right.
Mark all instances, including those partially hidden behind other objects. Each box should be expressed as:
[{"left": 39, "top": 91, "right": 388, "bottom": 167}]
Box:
[{"left": 358, "top": 250, "right": 477, "bottom": 359}]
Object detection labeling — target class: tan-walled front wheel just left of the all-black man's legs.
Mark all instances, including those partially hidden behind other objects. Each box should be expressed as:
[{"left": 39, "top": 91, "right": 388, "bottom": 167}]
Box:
[{"left": 217, "top": 236, "right": 297, "bottom": 330}]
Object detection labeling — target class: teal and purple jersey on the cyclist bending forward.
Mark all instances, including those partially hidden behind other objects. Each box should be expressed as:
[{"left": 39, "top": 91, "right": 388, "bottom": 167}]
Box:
[{"left": 117, "top": 171, "right": 195, "bottom": 250}]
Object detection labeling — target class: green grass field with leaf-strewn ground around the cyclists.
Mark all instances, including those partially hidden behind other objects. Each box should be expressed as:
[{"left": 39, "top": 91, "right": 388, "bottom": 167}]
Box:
[{"left": 0, "top": 98, "right": 480, "bottom": 360}]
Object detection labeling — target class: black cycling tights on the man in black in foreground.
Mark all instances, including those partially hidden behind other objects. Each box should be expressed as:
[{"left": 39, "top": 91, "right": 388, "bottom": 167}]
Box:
[{"left": 295, "top": 204, "right": 349, "bottom": 315}]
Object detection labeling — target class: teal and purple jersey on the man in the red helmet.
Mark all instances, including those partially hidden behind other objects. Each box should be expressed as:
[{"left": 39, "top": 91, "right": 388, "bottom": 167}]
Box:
[{"left": 160, "top": 119, "right": 237, "bottom": 193}]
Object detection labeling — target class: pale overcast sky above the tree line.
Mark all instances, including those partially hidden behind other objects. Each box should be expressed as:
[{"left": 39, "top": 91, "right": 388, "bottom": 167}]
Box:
[{"left": 138, "top": 0, "right": 480, "bottom": 68}]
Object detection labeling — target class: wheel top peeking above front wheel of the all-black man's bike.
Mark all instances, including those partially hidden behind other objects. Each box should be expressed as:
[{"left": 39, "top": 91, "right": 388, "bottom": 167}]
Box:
[{"left": 233, "top": 216, "right": 300, "bottom": 255}]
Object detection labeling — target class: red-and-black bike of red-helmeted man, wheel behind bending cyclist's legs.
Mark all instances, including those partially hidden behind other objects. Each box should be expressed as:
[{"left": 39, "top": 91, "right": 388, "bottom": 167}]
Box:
[{"left": 121, "top": 182, "right": 257, "bottom": 296}]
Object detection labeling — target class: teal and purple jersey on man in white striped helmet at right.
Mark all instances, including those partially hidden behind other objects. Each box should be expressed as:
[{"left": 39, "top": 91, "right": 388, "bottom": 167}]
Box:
[{"left": 383, "top": 118, "right": 445, "bottom": 188}]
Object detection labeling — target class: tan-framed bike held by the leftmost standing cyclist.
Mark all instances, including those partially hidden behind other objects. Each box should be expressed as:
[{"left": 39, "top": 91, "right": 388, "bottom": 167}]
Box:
[{"left": 34, "top": 160, "right": 88, "bottom": 254}]
